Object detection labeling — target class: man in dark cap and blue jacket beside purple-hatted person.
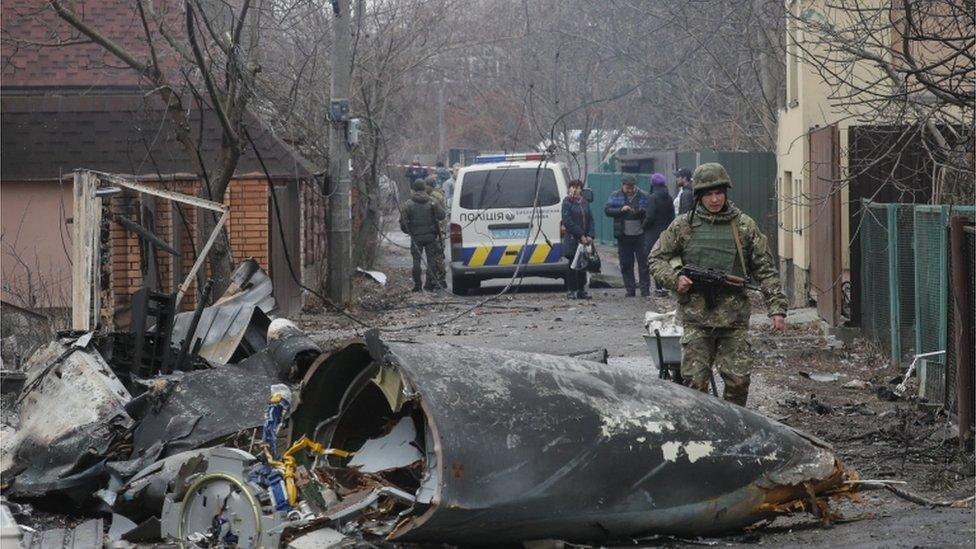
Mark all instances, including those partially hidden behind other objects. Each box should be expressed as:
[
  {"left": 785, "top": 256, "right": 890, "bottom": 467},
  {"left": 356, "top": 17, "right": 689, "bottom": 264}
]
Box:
[{"left": 603, "top": 174, "right": 651, "bottom": 297}]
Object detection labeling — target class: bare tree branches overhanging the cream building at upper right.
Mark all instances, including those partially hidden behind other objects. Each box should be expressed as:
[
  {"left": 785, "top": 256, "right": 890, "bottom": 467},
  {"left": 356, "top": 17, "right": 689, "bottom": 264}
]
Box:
[{"left": 790, "top": 0, "right": 976, "bottom": 204}]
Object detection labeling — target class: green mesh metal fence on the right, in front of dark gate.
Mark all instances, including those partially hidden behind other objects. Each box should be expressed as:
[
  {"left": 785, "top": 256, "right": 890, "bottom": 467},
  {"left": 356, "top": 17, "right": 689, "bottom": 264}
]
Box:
[{"left": 857, "top": 200, "right": 976, "bottom": 366}]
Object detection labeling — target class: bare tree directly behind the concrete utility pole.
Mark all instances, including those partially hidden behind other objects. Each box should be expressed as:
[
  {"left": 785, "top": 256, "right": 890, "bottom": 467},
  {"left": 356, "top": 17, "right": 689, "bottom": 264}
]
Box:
[{"left": 257, "top": 0, "right": 458, "bottom": 267}]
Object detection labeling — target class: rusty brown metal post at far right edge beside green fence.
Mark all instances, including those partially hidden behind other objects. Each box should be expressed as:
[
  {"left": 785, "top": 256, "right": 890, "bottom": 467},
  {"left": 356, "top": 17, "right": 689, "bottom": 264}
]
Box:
[{"left": 949, "top": 215, "right": 973, "bottom": 449}]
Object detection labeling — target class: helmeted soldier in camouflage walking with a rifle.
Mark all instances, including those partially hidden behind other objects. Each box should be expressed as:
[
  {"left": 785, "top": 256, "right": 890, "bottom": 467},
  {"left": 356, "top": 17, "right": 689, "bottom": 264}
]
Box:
[{"left": 648, "top": 163, "right": 787, "bottom": 406}]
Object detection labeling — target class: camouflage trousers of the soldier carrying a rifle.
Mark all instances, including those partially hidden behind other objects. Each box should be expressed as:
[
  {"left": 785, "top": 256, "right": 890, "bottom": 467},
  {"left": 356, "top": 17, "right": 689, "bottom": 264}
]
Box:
[{"left": 681, "top": 326, "right": 752, "bottom": 406}]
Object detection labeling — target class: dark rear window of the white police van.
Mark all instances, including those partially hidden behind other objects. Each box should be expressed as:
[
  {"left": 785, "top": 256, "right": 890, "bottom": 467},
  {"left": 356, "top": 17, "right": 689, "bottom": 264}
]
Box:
[{"left": 460, "top": 168, "right": 559, "bottom": 210}]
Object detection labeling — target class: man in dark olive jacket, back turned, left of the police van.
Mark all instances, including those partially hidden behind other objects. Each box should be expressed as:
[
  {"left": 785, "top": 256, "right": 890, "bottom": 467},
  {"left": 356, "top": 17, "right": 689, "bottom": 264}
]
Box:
[{"left": 400, "top": 179, "right": 446, "bottom": 292}]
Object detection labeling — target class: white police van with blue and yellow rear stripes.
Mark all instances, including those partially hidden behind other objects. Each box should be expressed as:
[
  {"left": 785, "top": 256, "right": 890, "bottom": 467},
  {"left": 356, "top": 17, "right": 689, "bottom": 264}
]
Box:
[{"left": 449, "top": 153, "right": 569, "bottom": 295}]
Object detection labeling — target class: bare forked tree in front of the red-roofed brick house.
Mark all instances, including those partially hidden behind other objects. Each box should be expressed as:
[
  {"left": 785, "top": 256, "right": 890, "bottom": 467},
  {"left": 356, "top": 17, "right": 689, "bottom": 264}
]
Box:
[{"left": 50, "top": 0, "right": 263, "bottom": 294}]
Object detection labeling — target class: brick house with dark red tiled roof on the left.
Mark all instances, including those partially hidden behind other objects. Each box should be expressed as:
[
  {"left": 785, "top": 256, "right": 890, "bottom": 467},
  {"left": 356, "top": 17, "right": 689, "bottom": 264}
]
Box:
[{"left": 0, "top": 0, "right": 326, "bottom": 318}]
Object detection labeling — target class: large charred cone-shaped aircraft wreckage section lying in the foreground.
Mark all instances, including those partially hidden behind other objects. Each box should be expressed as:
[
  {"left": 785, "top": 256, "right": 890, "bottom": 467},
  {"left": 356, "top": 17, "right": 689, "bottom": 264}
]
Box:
[{"left": 294, "top": 336, "right": 844, "bottom": 544}]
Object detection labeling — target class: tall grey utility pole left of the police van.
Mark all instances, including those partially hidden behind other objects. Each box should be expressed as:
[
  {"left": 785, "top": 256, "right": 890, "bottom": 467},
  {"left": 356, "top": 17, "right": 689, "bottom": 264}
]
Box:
[{"left": 326, "top": 0, "right": 352, "bottom": 307}]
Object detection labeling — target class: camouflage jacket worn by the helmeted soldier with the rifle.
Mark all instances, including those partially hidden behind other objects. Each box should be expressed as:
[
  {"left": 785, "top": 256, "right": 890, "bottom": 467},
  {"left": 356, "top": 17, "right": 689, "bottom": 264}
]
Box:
[{"left": 648, "top": 202, "right": 787, "bottom": 328}]
